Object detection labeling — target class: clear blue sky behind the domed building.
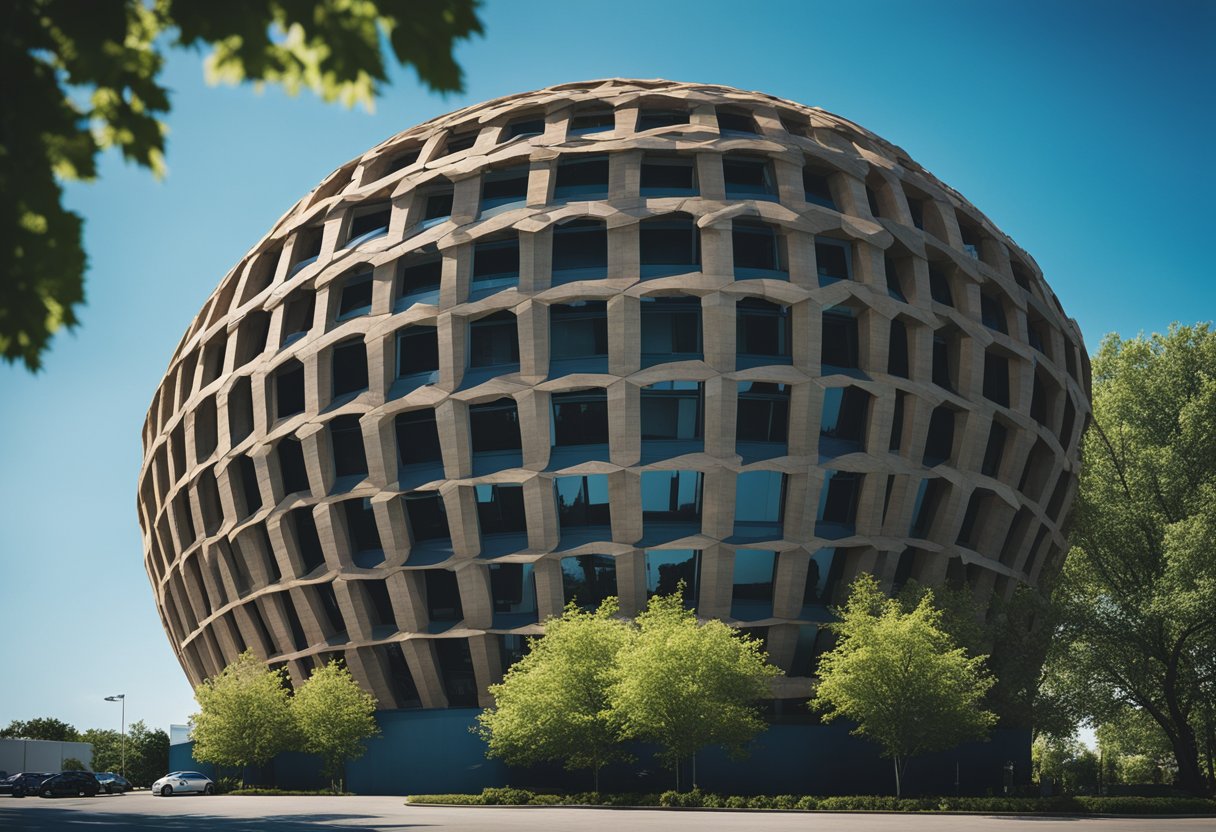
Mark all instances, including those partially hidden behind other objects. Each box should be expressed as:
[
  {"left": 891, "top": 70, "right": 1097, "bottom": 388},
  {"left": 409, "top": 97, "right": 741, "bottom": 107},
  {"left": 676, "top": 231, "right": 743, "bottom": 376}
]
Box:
[{"left": 0, "top": 0, "right": 1216, "bottom": 727}]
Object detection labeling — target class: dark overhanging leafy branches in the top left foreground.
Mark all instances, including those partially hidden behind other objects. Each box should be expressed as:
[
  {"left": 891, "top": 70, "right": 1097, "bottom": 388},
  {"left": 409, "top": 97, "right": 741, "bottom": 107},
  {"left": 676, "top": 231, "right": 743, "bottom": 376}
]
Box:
[{"left": 0, "top": 0, "right": 482, "bottom": 370}]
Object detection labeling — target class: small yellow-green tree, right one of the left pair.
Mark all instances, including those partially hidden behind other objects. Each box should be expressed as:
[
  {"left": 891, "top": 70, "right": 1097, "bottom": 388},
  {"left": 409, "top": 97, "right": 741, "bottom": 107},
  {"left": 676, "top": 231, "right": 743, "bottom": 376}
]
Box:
[{"left": 292, "top": 659, "right": 379, "bottom": 792}]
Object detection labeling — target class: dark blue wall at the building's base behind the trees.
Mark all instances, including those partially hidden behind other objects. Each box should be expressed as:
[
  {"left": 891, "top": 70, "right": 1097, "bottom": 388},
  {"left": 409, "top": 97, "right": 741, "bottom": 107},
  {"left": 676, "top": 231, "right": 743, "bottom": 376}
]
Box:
[{"left": 169, "top": 708, "right": 1030, "bottom": 794}]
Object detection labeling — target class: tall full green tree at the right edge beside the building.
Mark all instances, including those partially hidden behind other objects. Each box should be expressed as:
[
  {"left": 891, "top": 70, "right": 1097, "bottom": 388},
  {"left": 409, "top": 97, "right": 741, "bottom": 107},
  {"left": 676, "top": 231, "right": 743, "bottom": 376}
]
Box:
[{"left": 1047, "top": 325, "right": 1216, "bottom": 794}]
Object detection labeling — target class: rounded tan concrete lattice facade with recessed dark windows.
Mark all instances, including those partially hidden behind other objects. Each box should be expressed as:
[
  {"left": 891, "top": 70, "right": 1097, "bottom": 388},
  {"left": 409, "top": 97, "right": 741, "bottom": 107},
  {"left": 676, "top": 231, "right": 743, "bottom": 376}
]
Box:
[{"left": 139, "top": 80, "right": 1090, "bottom": 708}]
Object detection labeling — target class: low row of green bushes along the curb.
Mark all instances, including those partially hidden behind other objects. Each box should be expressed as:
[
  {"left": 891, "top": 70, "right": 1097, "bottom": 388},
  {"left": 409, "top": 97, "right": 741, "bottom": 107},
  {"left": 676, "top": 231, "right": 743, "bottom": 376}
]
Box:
[{"left": 407, "top": 786, "right": 1216, "bottom": 815}]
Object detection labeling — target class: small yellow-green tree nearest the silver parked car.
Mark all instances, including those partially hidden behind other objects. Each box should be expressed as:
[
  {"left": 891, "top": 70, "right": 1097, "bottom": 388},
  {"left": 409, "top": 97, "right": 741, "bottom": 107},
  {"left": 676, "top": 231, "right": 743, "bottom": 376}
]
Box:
[{"left": 190, "top": 651, "right": 297, "bottom": 778}]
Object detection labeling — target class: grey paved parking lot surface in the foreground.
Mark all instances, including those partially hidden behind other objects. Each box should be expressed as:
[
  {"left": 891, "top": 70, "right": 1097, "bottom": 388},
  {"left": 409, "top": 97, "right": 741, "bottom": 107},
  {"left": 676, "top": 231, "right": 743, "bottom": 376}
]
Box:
[{"left": 0, "top": 792, "right": 1214, "bottom": 832}]
